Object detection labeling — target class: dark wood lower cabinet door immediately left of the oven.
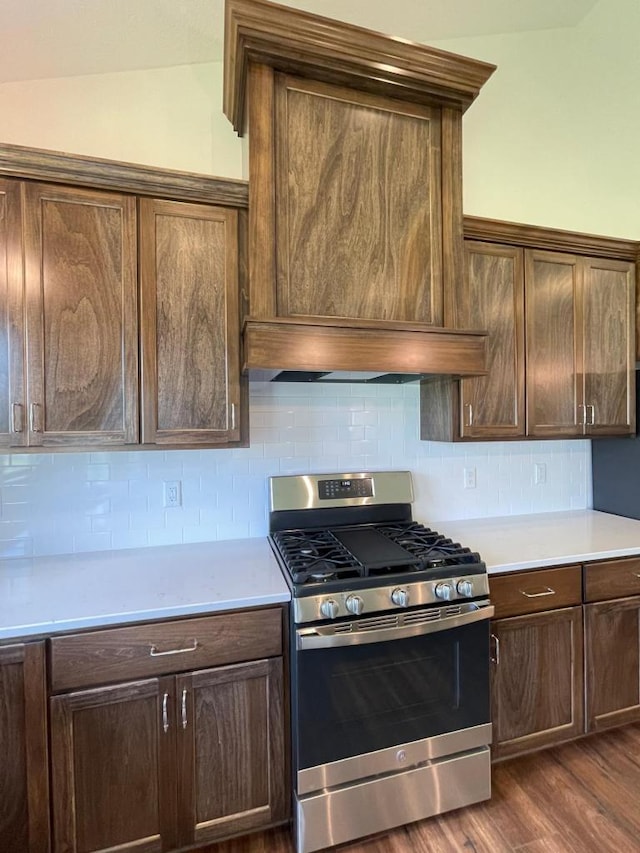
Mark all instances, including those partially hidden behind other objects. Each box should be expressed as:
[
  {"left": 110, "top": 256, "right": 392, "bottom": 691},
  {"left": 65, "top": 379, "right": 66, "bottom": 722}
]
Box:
[{"left": 176, "top": 658, "right": 289, "bottom": 845}]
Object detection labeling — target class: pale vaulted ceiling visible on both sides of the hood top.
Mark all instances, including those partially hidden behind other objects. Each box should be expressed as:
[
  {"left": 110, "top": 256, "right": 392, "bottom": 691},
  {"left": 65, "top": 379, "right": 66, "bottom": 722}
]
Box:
[{"left": 0, "top": 0, "right": 598, "bottom": 83}]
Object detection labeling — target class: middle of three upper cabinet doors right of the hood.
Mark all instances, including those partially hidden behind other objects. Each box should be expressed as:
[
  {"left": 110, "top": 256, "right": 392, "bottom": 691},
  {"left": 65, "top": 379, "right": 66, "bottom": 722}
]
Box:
[{"left": 525, "top": 250, "right": 584, "bottom": 437}]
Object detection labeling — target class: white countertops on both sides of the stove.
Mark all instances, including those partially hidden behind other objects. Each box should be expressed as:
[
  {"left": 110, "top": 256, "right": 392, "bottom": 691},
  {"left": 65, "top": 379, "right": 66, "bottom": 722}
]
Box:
[{"left": 0, "top": 510, "right": 640, "bottom": 640}]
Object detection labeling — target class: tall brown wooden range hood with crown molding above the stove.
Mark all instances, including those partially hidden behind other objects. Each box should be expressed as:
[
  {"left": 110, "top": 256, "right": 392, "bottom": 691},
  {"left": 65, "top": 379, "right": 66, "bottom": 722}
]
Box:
[{"left": 224, "top": 0, "right": 495, "bottom": 377}]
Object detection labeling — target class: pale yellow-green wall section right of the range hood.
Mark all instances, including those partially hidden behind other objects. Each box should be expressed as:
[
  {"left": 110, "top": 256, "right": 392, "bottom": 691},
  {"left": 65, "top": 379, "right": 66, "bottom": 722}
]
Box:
[{"left": 439, "top": 0, "right": 640, "bottom": 240}]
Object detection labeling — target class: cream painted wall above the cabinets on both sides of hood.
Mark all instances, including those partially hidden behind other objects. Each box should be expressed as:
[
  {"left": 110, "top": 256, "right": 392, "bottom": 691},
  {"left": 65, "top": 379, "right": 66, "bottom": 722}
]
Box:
[{"left": 0, "top": 0, "right": 640, "bottom": 239}]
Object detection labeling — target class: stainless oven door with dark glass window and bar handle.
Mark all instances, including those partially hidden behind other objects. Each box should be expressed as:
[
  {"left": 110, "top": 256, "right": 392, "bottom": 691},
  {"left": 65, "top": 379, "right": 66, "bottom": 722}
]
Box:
[{"left": 292, "top": 602, "right": 494, "bottom": 794}]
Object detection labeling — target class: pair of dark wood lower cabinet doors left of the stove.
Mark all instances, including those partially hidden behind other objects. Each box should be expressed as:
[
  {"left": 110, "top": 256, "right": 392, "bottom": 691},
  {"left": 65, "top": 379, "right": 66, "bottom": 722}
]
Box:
[{"left": 51, "top": 658, "right": 288, "bottom": 853}]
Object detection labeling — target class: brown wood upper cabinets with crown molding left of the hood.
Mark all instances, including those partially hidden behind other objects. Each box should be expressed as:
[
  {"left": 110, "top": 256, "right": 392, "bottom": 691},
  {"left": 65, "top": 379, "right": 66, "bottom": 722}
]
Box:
[{"left": 0, "top": 145, "right": 248, "bottom": 449}]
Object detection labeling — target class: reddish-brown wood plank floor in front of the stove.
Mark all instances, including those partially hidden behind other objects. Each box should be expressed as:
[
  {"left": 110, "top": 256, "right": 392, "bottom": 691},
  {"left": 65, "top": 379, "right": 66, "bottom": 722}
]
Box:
[{"left": 202, "top": 724, "right": 640, "bottom": 853}]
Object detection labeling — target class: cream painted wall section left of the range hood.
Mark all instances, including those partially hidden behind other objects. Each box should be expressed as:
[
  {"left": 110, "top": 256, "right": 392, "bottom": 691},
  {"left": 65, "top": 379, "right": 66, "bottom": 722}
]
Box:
[{"left": 0, "top": 63, "right": 242, "bottom": 178}]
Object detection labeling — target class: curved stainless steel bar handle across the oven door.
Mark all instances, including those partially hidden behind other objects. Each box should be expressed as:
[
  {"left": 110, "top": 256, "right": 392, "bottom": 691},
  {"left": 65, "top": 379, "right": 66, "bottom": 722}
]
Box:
[{"left": 296, "top": 604, "right": 495, "bottom": 651}]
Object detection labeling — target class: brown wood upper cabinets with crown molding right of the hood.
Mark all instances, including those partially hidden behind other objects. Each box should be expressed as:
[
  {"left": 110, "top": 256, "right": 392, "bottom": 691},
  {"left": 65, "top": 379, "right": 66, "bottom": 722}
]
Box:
[{"left": 421, "top": 218, "right": 635, "bottom": 441}]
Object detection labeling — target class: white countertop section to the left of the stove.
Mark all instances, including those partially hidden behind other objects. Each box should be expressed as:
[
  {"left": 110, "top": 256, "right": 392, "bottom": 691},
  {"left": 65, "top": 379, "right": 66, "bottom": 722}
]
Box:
[{"left": 0, "top": 538, "right": 290, "bottom": 640}]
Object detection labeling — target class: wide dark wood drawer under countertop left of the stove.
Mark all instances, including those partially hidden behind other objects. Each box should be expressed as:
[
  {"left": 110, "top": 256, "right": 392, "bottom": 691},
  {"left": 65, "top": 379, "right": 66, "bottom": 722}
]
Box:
[{"left": 51, "top": 608, "right": 282, "bottom": 691}]
